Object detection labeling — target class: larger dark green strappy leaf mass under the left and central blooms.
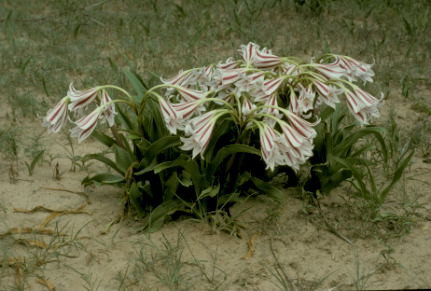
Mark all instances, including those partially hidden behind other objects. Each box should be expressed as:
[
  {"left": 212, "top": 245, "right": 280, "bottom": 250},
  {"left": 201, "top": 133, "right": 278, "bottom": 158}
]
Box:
[{"left": 82, "top": 71, "right": 282, "bottom": 230}]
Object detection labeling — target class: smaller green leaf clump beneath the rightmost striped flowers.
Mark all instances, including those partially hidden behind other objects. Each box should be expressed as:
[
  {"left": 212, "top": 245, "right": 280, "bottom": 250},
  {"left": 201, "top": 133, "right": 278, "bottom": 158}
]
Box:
[{"left": 304, "top": 106, "right": 387, "bottom": 194}]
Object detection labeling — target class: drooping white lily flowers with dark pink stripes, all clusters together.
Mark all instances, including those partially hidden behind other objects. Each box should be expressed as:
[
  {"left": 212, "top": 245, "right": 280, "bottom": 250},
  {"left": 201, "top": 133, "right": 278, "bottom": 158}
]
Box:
[{"left": 44, "top": 43, "right": 381, "bottom": 170}]
